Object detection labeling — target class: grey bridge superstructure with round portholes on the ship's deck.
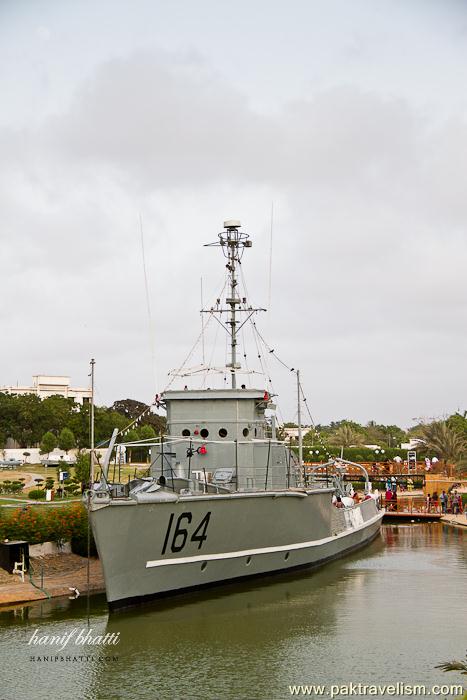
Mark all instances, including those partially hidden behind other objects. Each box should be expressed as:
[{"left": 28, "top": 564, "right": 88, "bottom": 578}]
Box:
[{"left": 151, "top": 388, "right": 297, "bottom": 491}]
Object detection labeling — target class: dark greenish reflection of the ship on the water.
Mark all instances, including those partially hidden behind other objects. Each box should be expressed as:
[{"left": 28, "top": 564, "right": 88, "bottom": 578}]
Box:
[{"left": 84, "top": 538, "right": 384, "bottom": 698}]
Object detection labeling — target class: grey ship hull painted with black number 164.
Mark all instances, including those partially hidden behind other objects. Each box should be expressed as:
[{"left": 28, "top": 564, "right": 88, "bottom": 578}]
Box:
[{"left": 91, "top": 489, "right": 382, "bottom": 609}]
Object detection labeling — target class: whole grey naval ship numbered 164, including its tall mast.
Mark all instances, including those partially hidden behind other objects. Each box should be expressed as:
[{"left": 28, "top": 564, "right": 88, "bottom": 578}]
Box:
[{"left": 87, "top": 220, "right": 383, "bottom": 609}]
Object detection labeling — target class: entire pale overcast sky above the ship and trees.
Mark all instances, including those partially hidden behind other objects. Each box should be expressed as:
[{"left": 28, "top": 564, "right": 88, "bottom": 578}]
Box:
[{"left": 0, "top": 0, "right": 467, "bottom": 426}]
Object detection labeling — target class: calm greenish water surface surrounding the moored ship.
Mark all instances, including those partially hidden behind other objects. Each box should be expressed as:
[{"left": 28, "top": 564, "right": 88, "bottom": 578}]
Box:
[{"left": 0, "top": 523, "right": 467, "bottom": 700}]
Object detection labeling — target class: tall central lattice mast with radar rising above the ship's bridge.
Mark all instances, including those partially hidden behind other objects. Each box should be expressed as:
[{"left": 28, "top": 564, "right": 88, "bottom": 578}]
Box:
[{"left": 202, "top": 219, "right": 265, "bottom": 389}]
